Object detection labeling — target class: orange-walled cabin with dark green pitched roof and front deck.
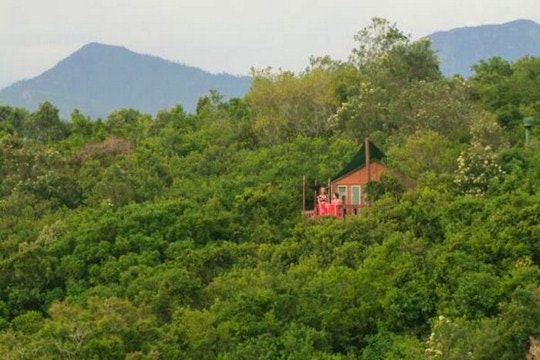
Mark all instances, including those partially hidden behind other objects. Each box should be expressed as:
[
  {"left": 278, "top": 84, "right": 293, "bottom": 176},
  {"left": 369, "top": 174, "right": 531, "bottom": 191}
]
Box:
[{"left": 303, "top": 138, "right": 388, "bottom": 218}]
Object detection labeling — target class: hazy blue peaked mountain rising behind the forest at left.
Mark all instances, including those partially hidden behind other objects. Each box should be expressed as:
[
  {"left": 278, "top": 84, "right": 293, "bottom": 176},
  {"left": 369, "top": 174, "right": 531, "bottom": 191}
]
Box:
[{"left": 0, "top": 43, "right": 251, "bottom": 118}]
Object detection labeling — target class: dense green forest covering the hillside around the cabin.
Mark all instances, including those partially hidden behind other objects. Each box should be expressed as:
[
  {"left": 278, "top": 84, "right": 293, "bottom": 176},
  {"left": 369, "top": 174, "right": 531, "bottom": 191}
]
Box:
[{"left": 0, "top": 19, "right": 540, "bottom": 360}]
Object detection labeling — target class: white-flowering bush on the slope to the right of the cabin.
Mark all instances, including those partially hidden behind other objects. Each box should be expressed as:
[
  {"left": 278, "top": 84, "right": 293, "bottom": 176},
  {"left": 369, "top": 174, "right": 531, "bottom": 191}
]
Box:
[{"left": 454, "top": 143, "right": 504, "bottom": 196}]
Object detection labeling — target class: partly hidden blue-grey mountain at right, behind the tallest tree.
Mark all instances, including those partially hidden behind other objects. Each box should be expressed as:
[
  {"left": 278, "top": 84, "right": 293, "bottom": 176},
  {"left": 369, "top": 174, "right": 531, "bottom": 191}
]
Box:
[{"left": 428, "top": 20, "right": 540, "bottom": 76}]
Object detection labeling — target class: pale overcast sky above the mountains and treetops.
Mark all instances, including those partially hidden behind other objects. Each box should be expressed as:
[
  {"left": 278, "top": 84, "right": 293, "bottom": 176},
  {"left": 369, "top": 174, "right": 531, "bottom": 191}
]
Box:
[{"left": 0, "top": 0, "right": 540, "bottom": 88}]
